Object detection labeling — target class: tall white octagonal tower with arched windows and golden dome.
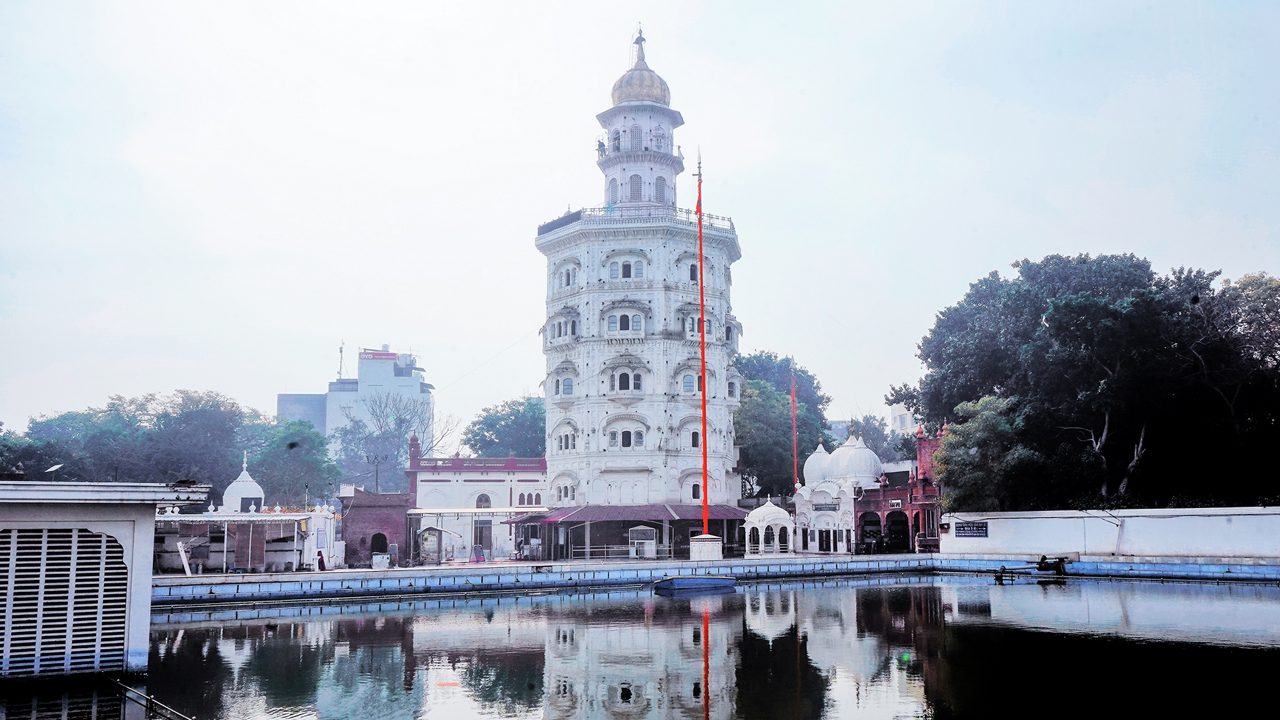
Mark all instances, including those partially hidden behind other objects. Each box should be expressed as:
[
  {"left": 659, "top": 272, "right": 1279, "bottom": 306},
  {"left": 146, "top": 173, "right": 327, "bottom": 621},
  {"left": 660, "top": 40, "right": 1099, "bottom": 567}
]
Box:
[{"left": 536, "top": 35, "right": 742, "bottom": 506}]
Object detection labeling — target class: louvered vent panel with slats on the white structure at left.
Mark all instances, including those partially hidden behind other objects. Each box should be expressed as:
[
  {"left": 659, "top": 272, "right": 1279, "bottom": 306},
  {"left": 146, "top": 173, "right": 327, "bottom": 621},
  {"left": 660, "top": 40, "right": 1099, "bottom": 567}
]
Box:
[{"left": 0, "top": 528, "right": 129, "bottom": 676}]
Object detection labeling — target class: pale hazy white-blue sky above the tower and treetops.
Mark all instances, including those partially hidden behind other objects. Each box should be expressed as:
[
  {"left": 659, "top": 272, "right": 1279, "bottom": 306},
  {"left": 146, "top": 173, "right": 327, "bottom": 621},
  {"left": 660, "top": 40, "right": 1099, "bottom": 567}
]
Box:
[{"left": 0, "top": 0, "right": 1280, "bottom": 448}]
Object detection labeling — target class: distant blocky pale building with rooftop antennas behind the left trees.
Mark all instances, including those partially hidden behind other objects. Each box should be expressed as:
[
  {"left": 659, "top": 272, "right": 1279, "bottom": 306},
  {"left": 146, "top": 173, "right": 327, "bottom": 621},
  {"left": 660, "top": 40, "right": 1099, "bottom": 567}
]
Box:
[{"left": 275, "top": 345, "right": 434, "bottom": 447}]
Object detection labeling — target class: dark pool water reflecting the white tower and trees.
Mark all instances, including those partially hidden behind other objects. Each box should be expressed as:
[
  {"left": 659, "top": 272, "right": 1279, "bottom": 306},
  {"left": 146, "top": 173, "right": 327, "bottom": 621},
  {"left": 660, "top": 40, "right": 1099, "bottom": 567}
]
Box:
[{"left": 0, "top": 577, "right": 1280, "bottom": 720}]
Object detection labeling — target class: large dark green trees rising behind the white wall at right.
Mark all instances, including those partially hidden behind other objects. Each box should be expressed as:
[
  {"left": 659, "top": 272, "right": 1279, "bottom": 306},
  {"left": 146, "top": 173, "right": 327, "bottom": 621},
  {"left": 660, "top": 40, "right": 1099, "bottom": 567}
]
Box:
[{"left": 887, "top": 255, "right": 1280, "bottom": 509}]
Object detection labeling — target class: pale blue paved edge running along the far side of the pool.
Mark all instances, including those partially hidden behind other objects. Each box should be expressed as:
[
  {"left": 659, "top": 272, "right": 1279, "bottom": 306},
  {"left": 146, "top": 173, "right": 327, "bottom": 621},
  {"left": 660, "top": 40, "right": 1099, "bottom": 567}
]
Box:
[{"left": 151, "top": 553, "right": 1280, "bottom": 606}]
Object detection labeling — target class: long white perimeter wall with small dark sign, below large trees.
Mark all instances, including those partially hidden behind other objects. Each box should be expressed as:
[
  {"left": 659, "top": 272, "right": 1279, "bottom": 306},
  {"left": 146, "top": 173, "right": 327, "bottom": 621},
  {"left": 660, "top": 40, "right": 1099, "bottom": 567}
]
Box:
[{"left": 941, "top": 507, "right": 1280, "bottom": 557}]
